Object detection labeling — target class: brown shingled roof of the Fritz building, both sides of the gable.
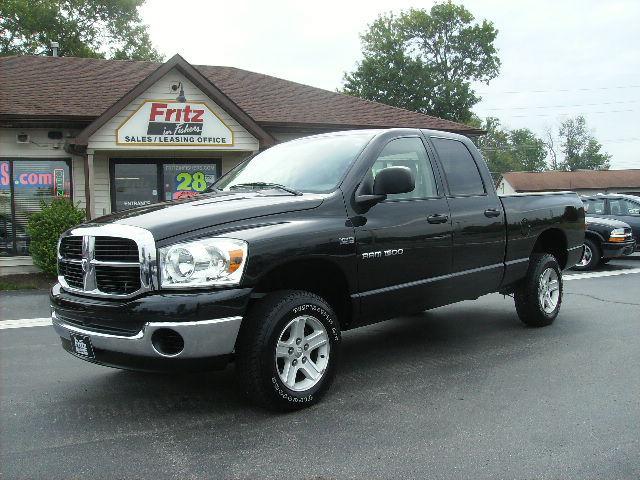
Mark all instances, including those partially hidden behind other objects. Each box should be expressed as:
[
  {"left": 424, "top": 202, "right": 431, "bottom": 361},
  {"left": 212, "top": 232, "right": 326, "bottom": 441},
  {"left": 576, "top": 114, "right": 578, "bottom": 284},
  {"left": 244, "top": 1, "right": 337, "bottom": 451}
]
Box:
[{"left": 0, "top": 56, "right": 483, "bottom": 134}]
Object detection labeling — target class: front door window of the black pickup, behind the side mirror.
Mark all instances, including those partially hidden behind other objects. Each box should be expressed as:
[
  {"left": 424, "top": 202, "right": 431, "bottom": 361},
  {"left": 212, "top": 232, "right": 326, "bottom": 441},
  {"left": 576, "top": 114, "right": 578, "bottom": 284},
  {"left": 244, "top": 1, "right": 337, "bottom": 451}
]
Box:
[{"left": 369, "top": 137, "right": 438, "bottom": 201}]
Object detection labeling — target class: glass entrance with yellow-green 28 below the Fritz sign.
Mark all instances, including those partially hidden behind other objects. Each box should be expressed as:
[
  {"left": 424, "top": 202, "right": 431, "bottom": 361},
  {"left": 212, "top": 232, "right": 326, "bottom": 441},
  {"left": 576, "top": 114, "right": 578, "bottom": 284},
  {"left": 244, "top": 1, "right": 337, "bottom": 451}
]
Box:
[{"left": 111, "top": 159, "right": 222, "bottom": 212}]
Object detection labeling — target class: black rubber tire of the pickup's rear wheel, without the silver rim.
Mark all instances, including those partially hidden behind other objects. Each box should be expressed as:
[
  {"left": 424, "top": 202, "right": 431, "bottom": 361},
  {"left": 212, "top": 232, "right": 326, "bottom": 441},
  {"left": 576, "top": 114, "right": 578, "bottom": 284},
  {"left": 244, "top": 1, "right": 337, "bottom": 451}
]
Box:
[{"left": 514, "top": 254, "right": 562, "bottom": 327}]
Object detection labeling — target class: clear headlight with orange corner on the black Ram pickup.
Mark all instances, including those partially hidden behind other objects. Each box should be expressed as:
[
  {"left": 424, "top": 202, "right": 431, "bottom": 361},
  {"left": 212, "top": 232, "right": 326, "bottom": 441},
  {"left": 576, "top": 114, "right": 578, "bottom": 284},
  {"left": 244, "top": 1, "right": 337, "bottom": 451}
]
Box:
[{"left": 160, "top": 238, "right": 247, "bottom": 288}]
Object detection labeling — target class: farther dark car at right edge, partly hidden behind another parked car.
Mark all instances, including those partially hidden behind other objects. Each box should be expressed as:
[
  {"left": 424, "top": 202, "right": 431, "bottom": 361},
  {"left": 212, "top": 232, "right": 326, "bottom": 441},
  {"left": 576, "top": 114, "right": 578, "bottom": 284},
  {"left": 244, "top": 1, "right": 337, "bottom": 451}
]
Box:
[{"left": 581, "top": 193, "right": 640, "bottom": 250}]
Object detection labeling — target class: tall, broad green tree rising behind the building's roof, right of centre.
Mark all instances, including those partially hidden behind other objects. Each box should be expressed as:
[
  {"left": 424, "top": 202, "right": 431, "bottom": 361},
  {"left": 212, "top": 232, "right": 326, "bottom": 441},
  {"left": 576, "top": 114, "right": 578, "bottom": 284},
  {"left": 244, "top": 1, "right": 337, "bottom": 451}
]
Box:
[{"left": 343, "top": 1, "right": 500, "bottom": 122}]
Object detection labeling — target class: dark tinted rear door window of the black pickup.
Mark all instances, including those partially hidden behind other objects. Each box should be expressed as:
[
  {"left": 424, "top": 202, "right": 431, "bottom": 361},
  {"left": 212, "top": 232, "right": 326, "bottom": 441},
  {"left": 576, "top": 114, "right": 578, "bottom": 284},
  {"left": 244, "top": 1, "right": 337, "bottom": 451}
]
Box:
[{"left": 431, "top": 138, "right": 487, "bottom": 197}]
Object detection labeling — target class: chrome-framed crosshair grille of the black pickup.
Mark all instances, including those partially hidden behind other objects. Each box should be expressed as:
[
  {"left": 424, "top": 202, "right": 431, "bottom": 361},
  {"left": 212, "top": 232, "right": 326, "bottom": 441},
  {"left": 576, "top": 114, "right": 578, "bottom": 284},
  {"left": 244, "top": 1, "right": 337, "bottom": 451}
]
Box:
[{"left": 58, "top": 224, "right": 157, "bottom": 297}]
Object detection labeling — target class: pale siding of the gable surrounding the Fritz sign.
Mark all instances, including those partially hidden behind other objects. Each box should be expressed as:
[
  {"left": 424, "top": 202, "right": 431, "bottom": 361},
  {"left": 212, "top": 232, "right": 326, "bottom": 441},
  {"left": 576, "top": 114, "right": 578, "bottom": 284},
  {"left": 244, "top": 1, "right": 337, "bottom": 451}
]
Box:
[{"left": 88, "top": 70, "right": 259, "bottom": 152}]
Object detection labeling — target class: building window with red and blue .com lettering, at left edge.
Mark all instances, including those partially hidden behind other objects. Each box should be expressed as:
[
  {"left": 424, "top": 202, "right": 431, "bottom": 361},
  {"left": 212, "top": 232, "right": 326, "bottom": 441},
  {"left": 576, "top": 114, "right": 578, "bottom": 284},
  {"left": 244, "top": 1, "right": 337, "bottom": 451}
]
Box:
[{"left": 0, "top": 158, "right": 72, "bottom": 256}]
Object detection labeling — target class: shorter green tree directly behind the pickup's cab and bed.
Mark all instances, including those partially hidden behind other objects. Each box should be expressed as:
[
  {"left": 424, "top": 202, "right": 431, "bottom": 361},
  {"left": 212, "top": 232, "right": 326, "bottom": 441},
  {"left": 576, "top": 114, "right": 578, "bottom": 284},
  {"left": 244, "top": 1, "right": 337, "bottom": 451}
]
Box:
[{"left": 475, "top": 117, "right": 547, "bottom": 178}]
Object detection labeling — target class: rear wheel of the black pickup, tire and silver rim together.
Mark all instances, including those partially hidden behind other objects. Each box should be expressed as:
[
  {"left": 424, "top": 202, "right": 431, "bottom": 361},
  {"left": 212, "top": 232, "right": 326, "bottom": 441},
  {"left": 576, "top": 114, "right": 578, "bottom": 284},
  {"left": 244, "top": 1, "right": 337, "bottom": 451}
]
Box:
[{"left": 514, "top": 254, "right": 562, "bottom": 327}]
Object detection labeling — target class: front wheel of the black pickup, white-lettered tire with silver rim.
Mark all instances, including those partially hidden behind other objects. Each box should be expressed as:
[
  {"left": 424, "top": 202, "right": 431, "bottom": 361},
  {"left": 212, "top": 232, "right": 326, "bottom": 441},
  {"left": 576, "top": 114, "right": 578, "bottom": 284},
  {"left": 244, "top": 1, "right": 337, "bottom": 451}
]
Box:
[{"left": 236, "top": 290, "right": 340, "bottom": 410}]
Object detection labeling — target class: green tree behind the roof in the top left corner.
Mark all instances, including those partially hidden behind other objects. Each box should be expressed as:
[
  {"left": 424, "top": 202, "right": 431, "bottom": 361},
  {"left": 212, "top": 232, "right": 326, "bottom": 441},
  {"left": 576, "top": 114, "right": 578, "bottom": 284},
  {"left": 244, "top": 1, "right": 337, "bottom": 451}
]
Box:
[{"left": 0, "top": 0, "right": 162, "bottom": 61}]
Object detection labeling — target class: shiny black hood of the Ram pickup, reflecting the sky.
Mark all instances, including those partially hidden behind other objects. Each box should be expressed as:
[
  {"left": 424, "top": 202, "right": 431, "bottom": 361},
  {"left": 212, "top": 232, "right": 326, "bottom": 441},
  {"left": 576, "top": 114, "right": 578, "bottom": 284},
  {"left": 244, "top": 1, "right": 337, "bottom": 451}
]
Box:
[{"left": 87, "top": 191, "right": 326, "bottom": 240}]
